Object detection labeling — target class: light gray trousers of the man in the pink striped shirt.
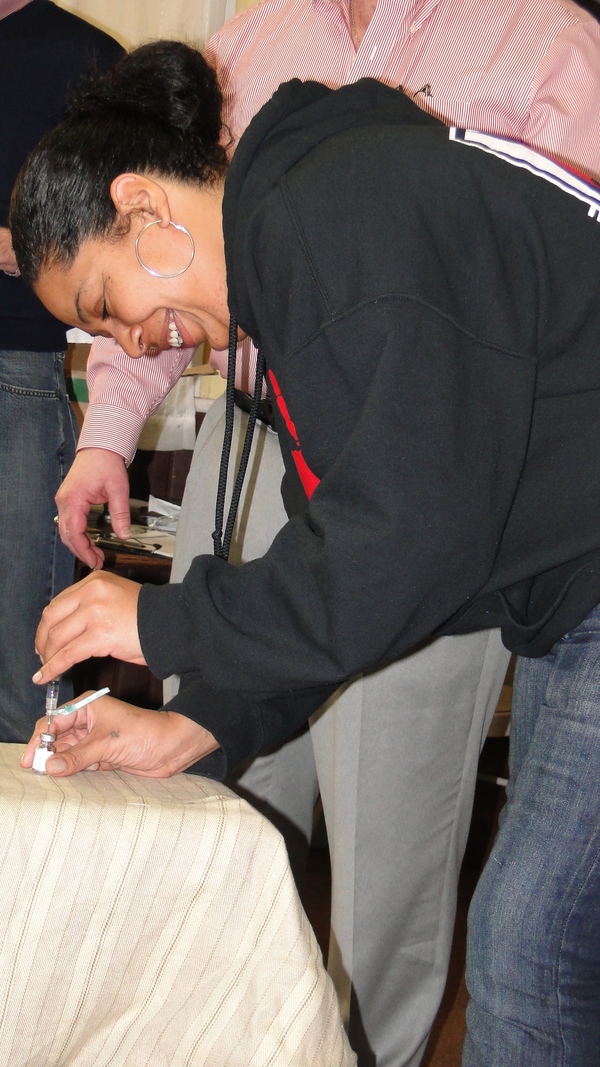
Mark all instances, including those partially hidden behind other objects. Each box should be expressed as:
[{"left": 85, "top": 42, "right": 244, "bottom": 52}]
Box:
[{"left": 165, "top": 400, "right": 508, "bottom": 1067}]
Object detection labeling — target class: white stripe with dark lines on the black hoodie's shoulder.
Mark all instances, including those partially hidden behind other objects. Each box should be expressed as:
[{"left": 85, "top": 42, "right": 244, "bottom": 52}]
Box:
[{"left": 449, "top": 126, "right": 600, "bottom": 221}]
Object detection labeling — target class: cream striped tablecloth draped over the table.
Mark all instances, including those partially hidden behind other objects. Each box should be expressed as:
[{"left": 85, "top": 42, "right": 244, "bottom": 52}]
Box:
[{"left": 0, "top": 745, "right": 356, "bottom": 1067}]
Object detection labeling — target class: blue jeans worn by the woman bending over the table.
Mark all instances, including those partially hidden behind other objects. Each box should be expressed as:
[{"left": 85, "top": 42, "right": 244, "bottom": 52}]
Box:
[{"left": 462, "top": 607, "right": 600, "bottom": 1067}]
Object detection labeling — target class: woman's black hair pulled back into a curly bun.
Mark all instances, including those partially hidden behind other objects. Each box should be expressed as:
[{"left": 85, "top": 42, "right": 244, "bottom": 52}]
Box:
[{"left": 9, "top": 41, "right": 227, "bottom": 286}]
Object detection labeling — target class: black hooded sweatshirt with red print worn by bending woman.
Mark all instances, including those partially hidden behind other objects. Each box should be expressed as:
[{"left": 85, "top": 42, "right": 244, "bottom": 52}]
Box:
[{"left": 138, "top": 81, "right": 600, "bottom": 776}]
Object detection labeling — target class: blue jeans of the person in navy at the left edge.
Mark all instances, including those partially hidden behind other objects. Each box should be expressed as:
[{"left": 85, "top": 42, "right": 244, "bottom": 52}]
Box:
[{"left": 0, "top": 350, "right": 76, "bottom": 742}]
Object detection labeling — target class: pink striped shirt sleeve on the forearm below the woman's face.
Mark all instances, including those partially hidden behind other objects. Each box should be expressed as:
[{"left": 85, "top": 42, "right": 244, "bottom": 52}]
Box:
[{"left": 77, "top": 337, "right": 195, "bottom": 463}]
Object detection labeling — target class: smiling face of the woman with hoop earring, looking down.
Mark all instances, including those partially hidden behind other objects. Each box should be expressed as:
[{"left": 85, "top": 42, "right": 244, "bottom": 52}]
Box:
[{"left": 35, "top": 179, "right": 230, "bottom": 356}]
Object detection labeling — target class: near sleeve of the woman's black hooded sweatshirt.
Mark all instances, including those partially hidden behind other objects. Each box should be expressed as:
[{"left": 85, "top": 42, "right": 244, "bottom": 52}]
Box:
[{"left": 138, "top": 296, "right": 536, "bottom": 766}]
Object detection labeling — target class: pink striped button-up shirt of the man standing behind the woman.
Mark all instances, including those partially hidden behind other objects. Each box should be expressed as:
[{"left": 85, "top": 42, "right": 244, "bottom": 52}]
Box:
[{"left": 79, "top": 0, "right": 600, "bottom": 462}]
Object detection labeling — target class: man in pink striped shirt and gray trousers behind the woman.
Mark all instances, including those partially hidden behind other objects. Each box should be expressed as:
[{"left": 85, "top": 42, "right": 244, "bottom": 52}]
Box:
[{"left": 50, "top": 0, "right": 600, "bottom": 1067}]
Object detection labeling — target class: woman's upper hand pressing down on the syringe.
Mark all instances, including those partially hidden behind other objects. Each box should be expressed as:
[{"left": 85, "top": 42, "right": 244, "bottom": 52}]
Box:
[{"left": 33, "top": 571, "right": 145, "bottom": 685}]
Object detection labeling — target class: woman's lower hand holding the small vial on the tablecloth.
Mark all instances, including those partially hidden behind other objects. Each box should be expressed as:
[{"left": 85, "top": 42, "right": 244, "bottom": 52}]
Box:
[{"left": 21, "top": 694, "right": 219, "bottom": 778}]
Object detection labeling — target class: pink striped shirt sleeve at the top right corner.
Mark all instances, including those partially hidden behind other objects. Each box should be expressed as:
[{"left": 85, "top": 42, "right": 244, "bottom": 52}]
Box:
[{"left": 522, "top": 16, "right": 600, "bottom": 179}]
